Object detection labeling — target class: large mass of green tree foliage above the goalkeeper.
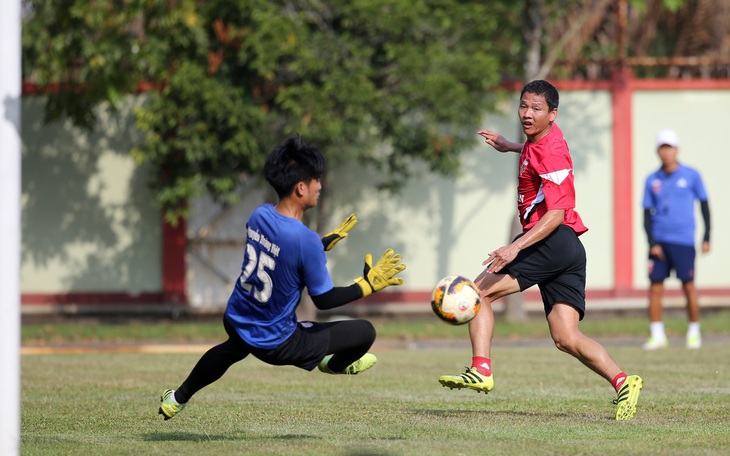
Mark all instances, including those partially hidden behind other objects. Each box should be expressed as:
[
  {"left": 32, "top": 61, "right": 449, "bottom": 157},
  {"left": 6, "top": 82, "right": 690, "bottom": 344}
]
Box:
[{"left": 23, "top": 0, "right": 521, "bottom": 219}]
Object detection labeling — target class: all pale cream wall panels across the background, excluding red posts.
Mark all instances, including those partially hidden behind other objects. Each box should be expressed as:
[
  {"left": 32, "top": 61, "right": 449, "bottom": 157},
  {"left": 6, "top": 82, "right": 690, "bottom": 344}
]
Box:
[{"left": 21, "top": 90, "right": 730, "bottom": 308}]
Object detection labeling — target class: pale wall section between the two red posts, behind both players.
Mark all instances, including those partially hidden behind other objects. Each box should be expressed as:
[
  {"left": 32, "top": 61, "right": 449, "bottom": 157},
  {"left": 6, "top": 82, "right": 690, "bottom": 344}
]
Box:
[{"left": 188, "top": 91, "right": 613, "bottom": 307}]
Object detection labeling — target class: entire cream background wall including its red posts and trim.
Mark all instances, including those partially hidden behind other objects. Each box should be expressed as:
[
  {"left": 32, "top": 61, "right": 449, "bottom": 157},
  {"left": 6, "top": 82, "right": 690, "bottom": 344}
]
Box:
[{"left": 22, "top": 73, "right": 730, "bottom": 314}]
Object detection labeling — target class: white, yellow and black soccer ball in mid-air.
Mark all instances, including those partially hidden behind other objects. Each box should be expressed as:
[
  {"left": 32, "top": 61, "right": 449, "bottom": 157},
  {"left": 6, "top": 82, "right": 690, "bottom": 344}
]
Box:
[{"left": 431, "top": 275, "right": 481, "bottom": 325}]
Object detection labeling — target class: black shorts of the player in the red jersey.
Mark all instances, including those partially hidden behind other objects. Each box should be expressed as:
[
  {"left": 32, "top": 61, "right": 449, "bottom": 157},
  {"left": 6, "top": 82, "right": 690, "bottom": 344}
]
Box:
[{"left": 499, "top": 225, "right": 586, "bottom": 320}]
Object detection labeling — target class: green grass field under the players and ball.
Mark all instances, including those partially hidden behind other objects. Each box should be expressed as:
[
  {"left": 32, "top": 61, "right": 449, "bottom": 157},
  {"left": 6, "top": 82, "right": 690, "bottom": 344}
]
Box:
[{"left": 21, "top": 315, "right": 730, "bottom": 456}]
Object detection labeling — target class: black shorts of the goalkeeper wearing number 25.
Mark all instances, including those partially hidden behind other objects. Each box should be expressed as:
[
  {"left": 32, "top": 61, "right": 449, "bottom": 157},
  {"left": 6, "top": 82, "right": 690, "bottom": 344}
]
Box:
[{"left": 223, "top": 317, "right": 330, "bottom": 371}]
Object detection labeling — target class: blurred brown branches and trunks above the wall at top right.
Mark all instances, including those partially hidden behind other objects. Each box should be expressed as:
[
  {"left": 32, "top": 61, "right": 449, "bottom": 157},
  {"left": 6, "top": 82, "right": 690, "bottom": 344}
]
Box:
[{"left": 530, "top": 0, "right": 730, "bottom": 79}]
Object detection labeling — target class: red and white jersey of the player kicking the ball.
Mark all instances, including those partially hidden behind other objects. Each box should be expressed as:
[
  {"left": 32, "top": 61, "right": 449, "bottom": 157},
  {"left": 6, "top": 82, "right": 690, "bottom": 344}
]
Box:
[{"left": 517, "top": 123, "right": 588, "bottom": 235}]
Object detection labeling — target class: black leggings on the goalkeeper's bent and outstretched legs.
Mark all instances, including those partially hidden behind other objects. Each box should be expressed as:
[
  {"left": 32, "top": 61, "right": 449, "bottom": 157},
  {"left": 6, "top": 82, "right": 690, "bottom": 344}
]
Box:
[{"left": 175, "top": 317, "right": 375, "bottom": 404}]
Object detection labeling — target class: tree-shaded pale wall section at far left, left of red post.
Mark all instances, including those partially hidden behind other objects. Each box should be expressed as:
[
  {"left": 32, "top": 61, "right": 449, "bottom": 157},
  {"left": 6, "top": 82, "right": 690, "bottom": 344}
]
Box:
[{"left": 21, "top": 97, "right": 162, "bottom": 294}]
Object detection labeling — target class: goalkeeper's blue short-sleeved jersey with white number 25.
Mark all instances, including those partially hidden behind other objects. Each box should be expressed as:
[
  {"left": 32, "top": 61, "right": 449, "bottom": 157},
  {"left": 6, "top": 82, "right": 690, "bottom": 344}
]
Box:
[{"left": 226, "top": 204, "right": 332, "bottom": 349}]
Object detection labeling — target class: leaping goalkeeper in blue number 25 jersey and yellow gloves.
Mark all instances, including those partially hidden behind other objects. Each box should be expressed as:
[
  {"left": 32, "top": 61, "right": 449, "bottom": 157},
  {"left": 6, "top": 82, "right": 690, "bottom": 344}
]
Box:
[{"left": 159, "top": 135, "right": 406, "bottom": 420}]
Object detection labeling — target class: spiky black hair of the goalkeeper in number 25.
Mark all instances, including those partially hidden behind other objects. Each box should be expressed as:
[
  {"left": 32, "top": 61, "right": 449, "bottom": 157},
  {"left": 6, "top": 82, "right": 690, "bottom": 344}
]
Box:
[{"left": 264, "top": 134, "right": 327, "bottom": 198}]
